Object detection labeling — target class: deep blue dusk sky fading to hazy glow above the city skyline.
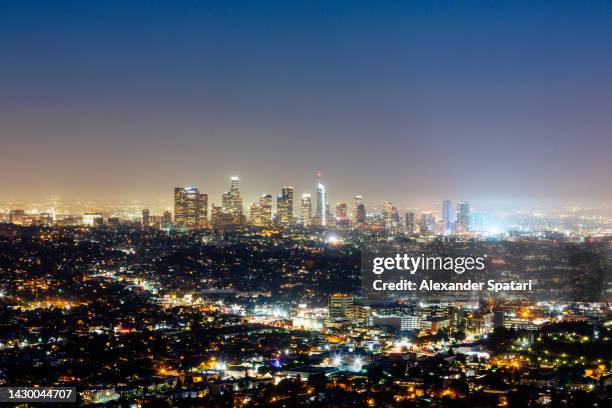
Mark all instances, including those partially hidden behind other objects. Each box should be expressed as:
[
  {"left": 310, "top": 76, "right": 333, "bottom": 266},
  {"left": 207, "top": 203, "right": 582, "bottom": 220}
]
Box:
[{"left": 0, "top": 0, "right": 612, "bottom": 210}]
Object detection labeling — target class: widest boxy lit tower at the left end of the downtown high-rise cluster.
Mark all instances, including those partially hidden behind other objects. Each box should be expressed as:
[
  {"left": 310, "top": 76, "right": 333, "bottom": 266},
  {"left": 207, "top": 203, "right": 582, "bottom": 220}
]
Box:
[{"left": 174, "top": 187, "right": 208, "bottom": 228}]
